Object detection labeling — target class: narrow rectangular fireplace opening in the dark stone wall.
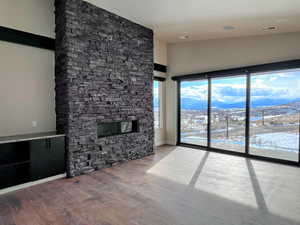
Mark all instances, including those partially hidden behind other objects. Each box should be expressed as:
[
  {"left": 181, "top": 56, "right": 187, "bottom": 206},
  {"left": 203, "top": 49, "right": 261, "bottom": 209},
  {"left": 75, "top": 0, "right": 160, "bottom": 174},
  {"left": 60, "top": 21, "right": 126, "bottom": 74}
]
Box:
[{"left": 97, "top": 120, "right": 139, "bottom": 138}]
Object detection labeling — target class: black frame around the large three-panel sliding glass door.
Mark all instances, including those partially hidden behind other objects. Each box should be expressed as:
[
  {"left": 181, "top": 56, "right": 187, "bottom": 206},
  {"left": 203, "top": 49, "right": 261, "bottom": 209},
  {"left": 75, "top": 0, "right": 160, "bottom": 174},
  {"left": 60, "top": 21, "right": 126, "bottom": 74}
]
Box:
[{"left": 172, "top": 59, "right": 300, "bottom": 167}]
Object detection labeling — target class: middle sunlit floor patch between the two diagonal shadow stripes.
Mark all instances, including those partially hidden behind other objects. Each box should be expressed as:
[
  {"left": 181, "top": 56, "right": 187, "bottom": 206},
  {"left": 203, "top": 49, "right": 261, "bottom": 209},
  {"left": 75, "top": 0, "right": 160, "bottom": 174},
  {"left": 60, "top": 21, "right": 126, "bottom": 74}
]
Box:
[{"left": 195, "top": 153, "right": 258, "bottom": 208}]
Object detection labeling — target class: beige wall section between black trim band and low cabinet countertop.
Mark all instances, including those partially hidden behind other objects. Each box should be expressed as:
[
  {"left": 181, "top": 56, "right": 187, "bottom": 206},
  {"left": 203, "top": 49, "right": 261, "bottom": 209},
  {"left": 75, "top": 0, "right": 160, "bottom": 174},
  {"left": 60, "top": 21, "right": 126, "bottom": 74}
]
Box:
[{"left": 0, "top": 41, "right": 56, "bottom": 136}]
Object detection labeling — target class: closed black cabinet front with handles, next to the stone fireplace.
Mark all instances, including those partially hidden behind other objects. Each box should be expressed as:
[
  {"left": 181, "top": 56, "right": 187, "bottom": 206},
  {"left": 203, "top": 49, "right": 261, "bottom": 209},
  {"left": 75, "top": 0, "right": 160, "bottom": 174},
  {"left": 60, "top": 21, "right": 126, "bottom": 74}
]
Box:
[{"left": 31, "top": 137, "right": 65, "bottom": 180}]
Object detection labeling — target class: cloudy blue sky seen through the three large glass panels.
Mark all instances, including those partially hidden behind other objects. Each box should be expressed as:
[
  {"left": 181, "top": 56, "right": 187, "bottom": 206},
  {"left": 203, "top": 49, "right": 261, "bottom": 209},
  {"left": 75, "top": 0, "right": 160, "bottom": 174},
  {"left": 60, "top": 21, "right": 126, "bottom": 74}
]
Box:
[{"left": 181, "top": 70, "right": 300, "bottom": 103}]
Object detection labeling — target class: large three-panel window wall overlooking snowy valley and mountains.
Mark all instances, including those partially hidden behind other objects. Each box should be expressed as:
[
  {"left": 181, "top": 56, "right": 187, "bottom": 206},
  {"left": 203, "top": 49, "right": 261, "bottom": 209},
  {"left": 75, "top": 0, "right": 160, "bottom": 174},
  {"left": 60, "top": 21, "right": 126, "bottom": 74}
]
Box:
[{"left": 178, "top": 61, "right": 300, "bottom": 163}]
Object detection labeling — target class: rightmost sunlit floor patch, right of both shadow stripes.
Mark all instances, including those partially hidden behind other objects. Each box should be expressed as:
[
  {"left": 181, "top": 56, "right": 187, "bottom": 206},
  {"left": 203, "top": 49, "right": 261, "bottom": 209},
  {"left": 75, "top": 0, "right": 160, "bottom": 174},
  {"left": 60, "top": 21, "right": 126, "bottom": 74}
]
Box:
[{"left": 252, "top": 161, "right": 300, "bottom": 224}]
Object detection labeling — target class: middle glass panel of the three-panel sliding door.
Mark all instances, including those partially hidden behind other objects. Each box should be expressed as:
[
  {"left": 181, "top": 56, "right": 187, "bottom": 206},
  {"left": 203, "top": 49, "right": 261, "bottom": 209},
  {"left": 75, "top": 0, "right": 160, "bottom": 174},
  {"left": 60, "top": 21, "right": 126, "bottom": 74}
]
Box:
[{"left": 210, "top": 76, "right": 247, "bottom": 153}]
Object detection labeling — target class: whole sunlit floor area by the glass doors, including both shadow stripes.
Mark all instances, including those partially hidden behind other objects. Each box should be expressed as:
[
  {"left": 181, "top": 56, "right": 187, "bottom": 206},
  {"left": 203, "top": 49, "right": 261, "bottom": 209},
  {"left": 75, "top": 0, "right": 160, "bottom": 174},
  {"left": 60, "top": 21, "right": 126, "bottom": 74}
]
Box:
[{"left": 147, "top": 147, "right": 300, "bottom": 222}]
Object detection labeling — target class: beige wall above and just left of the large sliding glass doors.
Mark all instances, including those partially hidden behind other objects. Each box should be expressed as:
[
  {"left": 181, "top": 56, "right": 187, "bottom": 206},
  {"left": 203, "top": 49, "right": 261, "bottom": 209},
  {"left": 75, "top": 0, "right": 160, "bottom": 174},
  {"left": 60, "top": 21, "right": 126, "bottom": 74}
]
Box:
[{"left": 166, "top": 32, "right": 300, "bottom": 144}]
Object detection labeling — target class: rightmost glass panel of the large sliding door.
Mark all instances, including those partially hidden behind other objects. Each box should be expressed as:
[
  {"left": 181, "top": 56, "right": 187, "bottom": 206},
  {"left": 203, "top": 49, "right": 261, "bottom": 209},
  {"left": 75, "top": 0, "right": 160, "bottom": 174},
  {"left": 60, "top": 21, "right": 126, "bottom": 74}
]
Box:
[{"left": 249, "top": 70, "right": 300, "bottom": 161}]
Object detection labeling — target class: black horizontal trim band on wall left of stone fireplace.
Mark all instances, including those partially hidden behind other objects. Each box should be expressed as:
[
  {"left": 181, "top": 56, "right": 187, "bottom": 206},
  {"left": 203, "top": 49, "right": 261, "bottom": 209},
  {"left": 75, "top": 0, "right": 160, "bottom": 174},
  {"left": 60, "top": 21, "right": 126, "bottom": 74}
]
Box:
[{"left": 0, "top": 26, "right": 55, "bottom": 50}]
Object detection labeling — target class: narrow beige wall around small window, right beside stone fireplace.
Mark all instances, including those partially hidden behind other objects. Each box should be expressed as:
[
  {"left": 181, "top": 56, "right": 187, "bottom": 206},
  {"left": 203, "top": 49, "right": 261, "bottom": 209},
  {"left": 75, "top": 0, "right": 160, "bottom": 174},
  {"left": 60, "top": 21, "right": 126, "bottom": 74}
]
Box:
[{"left": 154, "top": 39, "right": 167, "bottom": 146}]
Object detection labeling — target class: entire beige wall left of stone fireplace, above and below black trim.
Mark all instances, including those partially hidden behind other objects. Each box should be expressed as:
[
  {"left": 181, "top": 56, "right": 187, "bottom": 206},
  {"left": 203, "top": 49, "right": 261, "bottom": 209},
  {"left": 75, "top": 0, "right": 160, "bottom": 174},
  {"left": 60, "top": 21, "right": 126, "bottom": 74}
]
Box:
[{"left": 0, "top": 0, "right": 56, "bottom": 136}]
